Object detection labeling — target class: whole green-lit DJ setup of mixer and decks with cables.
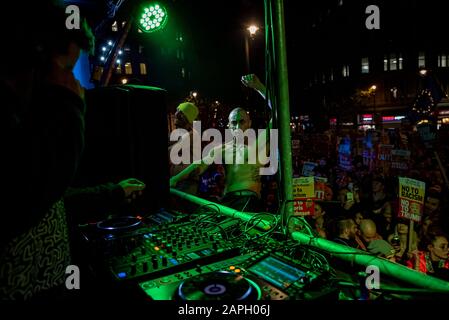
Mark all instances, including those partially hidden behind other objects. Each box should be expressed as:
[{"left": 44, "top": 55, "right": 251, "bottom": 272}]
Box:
[{"left": 78, "top": 211, "right": 338, "bottom": 301}]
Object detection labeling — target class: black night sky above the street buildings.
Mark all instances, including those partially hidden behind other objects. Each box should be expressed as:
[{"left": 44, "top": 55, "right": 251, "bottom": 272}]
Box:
[{"left": 68, "top": 0, "right": 445, "bottom": 109}]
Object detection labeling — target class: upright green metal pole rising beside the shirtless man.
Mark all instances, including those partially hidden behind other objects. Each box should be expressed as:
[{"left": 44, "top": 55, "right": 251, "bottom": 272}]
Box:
[{"left": 273, "top": 0, "right": 293, "bottom": 230}]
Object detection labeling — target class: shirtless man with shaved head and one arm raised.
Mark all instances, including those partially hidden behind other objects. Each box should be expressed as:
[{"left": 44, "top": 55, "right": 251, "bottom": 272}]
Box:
[{"left": 170, "top": 75, "right": 268, "bottom": 212}]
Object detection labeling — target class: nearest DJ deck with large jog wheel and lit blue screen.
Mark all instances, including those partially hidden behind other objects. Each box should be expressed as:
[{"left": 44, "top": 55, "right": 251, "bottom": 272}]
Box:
[{"left": 139, "top": 249, "right": 338, "bottom": 301}]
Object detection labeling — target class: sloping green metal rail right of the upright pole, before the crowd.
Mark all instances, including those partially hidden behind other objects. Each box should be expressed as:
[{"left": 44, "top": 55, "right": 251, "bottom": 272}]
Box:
[{"left": 292, "top": 232, "right": 449, "bottom": 292}]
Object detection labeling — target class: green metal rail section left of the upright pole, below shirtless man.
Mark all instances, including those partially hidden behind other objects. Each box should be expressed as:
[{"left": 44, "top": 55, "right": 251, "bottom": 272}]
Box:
[{"left": 170, "top": 188, "right": 271, "bottom": 230}]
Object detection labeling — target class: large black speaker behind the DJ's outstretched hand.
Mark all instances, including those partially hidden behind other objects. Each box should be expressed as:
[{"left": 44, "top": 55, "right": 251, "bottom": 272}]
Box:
[{"left": 75, "top": 85, "right": 169, "bottom": 214}]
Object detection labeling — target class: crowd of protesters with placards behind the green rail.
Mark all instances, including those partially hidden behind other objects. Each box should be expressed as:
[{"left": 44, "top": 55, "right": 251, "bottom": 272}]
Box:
[{"left": 288, "top": 127, "right": 449, "bottom": 280}]
